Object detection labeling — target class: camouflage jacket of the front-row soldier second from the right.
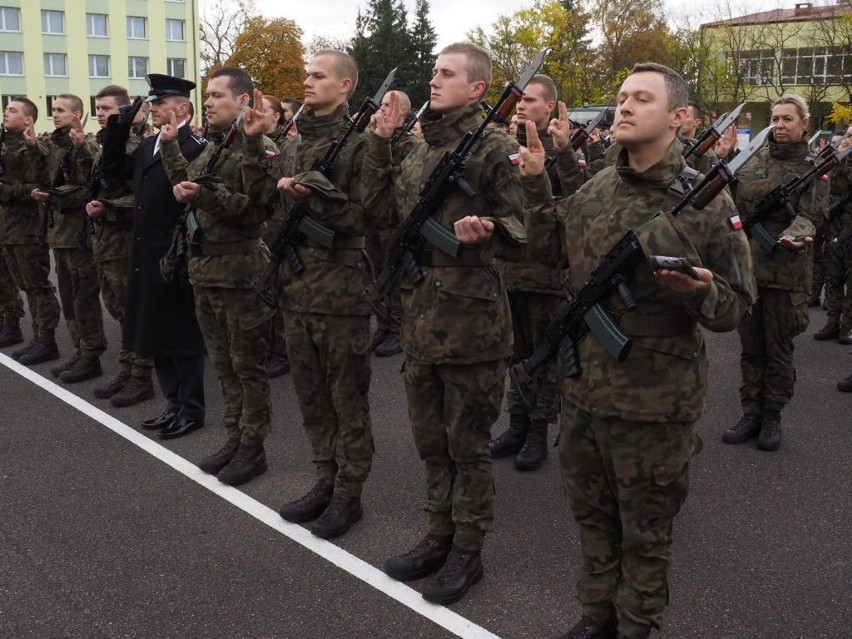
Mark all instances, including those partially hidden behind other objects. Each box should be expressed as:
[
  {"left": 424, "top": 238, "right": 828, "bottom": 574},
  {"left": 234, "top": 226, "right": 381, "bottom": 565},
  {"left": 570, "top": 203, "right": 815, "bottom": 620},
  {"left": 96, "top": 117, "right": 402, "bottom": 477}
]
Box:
[{"left": 364, "top": 104, "right": 526, "bottom": 364}]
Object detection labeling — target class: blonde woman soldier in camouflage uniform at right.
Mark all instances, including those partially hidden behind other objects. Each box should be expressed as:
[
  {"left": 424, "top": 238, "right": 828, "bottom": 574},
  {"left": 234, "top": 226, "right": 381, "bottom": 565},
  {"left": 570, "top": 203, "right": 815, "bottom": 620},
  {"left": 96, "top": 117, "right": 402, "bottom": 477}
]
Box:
[{"left": 722, "top": 95, "right": 829, "bottom": 451}]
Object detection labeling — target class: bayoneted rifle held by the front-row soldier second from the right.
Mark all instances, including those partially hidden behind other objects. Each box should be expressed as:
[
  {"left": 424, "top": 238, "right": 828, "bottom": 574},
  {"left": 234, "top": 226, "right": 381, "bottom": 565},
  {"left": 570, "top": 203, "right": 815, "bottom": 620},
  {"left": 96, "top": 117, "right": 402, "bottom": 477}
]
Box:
[{"left": 364, "top": 49, "right": 547, "bottom": 318}]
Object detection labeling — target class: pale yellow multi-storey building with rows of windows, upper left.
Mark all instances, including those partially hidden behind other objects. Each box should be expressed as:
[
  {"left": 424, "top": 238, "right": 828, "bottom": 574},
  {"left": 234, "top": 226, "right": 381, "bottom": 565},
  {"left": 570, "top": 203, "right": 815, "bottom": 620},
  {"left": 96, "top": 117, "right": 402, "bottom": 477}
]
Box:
[{"left": 0, "top": 0, "right": 200, "bottom": 132}]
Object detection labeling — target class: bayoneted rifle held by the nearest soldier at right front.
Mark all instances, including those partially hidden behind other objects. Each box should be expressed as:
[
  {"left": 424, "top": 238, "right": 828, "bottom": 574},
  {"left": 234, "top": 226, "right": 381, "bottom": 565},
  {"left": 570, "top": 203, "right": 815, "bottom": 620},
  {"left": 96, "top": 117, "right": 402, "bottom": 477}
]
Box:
[{"left": 509, "top": 127, "right": 772, "bottom": 408}]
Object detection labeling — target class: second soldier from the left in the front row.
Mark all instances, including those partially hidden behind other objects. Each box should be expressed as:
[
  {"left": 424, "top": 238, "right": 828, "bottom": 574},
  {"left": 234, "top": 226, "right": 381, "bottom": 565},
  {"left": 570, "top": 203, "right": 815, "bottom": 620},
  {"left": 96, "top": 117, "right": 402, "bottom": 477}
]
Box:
[{"left": 31, "top": 94, "right": 106, "bottom": 384}]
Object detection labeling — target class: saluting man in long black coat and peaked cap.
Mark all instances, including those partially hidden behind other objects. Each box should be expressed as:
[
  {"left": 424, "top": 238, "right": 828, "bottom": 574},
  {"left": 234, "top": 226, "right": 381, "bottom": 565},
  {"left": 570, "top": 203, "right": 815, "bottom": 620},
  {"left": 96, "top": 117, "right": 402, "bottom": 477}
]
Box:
[{"left": 98, "top": 73, "right": 207, "bottom": 439}]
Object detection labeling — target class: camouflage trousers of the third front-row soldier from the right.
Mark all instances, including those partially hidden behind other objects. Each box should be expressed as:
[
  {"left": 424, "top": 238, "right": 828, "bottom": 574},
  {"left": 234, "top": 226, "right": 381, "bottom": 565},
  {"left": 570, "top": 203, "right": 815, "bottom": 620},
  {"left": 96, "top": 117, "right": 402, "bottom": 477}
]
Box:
[{"left": 284, "top": 311, "right": 374, "bottom": 497}]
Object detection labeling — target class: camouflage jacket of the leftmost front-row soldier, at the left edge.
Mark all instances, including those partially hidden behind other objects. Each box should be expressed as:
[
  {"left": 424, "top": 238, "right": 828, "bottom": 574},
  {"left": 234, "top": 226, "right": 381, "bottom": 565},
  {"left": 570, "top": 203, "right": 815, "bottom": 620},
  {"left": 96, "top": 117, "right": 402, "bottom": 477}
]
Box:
[{"left": 0, "top": 131, "right": 49, "bottom": 244}]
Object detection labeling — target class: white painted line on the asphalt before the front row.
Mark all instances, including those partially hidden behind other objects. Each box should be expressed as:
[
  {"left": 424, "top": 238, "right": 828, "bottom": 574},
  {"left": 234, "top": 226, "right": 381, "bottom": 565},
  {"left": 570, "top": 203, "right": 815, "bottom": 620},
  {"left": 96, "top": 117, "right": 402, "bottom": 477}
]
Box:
[{"left": 0, "top": 353, "right": 500, "bottom": 639}]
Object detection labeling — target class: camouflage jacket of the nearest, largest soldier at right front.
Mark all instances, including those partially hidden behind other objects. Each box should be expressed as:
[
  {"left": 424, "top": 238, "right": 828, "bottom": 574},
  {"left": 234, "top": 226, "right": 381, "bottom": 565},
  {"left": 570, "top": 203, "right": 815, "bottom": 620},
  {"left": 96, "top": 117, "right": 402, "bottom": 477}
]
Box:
[{"left": 524, "top": 142, "right": 755, "bottom": 422}]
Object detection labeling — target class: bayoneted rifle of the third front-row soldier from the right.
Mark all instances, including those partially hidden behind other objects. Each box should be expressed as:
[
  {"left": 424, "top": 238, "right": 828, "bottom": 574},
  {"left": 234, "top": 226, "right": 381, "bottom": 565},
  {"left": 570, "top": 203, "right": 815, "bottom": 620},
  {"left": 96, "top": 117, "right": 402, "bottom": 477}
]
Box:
[{"left": 254, "top": 69, "right": 396, "bottom": 308}]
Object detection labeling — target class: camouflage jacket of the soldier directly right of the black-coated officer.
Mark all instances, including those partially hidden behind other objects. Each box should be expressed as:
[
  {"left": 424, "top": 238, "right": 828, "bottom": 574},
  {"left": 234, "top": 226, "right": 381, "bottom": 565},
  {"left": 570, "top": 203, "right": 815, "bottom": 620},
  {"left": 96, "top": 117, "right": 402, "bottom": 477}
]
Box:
[{"left": 160, "top": 125, "right": 278, "bottom": 288}]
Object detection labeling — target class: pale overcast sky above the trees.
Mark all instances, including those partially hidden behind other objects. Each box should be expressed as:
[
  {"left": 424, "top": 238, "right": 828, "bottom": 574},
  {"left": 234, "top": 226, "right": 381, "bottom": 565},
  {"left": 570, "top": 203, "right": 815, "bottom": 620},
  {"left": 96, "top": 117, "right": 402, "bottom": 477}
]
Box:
[{"left": 251, "top": 0, "right": 800, "bottom": 47}]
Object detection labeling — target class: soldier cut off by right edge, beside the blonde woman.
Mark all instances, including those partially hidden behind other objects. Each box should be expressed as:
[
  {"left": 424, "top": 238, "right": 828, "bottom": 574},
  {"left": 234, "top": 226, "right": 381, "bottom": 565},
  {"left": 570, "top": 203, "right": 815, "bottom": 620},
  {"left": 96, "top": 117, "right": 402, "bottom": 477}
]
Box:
[{"left": 814, "top": 132, "right": 852, "bottom": 344}]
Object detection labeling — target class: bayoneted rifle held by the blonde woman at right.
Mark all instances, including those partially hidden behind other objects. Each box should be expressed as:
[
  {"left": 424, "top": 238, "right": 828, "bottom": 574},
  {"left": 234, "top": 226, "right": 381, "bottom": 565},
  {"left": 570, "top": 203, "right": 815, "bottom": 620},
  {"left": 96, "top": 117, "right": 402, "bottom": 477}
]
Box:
[{"left": 728, "top": 146, "right": 852, "bottom": 255}]
